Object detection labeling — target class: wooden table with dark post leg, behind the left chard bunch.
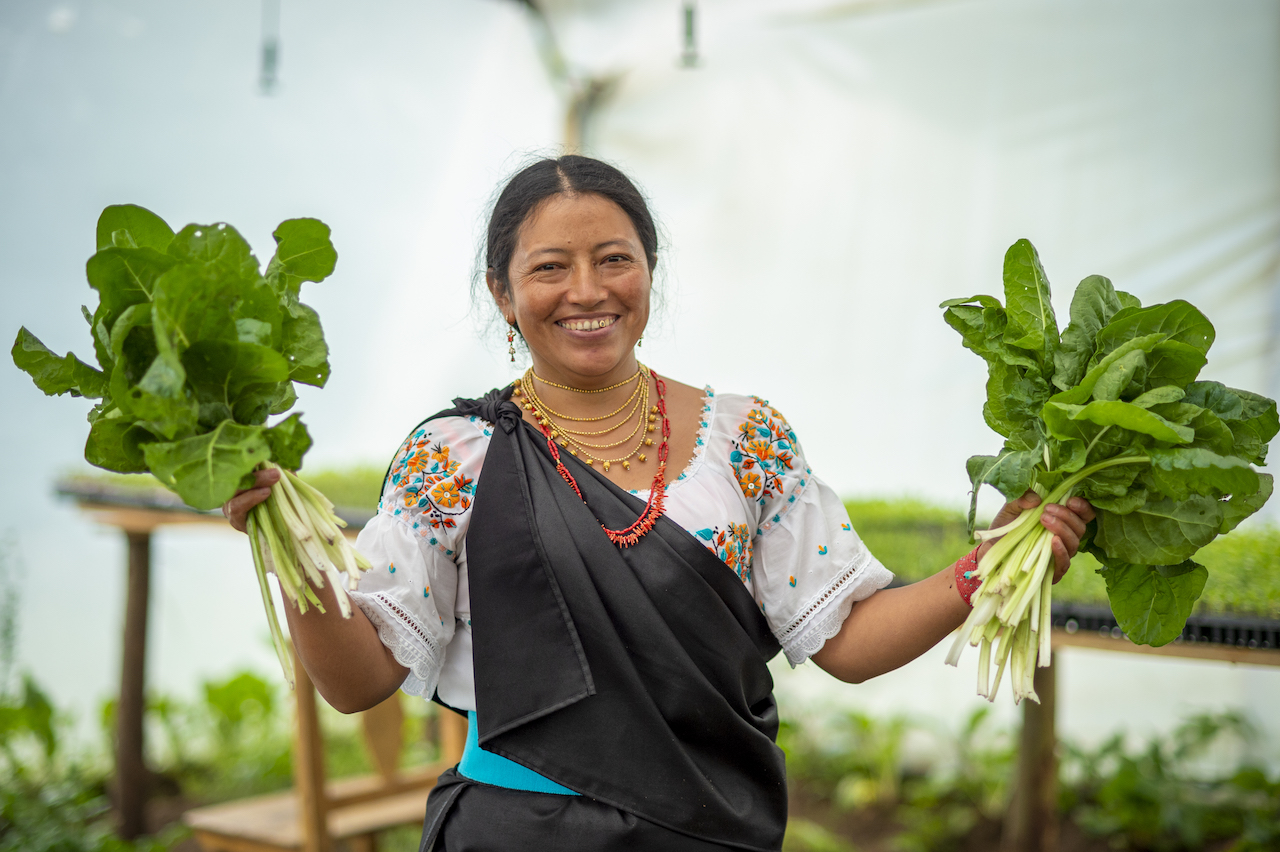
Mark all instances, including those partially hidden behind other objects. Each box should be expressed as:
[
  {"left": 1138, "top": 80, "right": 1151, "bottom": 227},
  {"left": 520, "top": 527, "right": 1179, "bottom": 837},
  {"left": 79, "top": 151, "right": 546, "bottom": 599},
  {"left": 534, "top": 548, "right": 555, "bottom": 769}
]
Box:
[{"left": 56, "top": 477, "right": 372, "bottom": 839}]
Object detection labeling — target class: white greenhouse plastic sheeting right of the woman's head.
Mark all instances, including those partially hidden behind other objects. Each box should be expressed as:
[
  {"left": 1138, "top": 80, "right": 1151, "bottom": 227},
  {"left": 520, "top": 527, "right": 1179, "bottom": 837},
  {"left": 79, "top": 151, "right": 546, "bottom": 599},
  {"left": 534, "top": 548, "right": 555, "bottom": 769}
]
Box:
[{"left": 491, "top": 0, "right": 1280, "bottom": 511}]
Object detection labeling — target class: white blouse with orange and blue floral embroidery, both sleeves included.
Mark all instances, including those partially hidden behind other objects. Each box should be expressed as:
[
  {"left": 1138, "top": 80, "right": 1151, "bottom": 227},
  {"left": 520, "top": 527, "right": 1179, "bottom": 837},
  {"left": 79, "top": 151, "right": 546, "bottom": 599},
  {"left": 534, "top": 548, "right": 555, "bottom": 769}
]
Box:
[{"left": 352, "top": 388, "right": 893, "bottom": 710}]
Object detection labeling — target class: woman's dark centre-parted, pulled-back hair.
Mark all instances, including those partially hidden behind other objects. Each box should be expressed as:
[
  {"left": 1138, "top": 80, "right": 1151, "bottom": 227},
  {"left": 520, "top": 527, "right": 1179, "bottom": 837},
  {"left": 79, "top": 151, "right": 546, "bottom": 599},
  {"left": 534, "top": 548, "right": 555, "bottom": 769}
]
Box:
[{"left": 484, "top": 154, "right": 658, "bottom": 294}]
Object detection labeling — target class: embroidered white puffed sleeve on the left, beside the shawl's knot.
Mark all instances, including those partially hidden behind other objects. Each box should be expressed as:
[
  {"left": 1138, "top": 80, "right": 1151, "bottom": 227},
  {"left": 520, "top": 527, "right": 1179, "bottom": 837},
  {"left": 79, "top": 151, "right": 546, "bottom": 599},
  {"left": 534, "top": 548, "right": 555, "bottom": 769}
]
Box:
[{"left": 352, "top": 417, "right": 489, "bottom": 698}]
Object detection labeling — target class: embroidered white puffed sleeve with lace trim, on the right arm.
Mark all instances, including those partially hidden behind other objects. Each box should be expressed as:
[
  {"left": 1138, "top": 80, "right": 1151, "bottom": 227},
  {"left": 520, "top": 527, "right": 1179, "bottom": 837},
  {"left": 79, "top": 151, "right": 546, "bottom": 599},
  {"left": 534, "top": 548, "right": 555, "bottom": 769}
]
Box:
[{"left": 730, "top": 398, "right": 893, "bottom": 667}]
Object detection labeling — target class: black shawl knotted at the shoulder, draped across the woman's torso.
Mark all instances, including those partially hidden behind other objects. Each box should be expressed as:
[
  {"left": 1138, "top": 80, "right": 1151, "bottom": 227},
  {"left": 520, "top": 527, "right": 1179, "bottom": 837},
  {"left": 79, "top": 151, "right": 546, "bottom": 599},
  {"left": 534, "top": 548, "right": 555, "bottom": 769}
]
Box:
[{"left": 419, "top": 388, "right": 786, "bottom": 849}]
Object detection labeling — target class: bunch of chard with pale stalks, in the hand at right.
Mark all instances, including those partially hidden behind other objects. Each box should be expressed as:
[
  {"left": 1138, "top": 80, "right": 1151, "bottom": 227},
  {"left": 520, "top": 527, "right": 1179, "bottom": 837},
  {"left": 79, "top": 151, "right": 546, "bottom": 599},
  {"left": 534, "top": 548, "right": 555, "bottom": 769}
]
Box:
[{"left": 941, "top": 239, "right": 1280, "bottom": 701}]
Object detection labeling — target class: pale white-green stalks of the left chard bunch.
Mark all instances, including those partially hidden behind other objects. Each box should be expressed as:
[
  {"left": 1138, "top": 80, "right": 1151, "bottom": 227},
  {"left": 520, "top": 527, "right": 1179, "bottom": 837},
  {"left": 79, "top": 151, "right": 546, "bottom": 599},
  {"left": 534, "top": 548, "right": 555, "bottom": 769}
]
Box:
[{"left": 248, "top": 462, "right": 371, "bottom": 690}]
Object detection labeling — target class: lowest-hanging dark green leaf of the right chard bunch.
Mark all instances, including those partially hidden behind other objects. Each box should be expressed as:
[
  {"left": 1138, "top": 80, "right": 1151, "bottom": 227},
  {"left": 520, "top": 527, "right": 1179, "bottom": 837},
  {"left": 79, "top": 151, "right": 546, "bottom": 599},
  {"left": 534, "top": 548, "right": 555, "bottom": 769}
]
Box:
[{"left": 1101, "top": 559, "right": 1208, "bottom": 646}]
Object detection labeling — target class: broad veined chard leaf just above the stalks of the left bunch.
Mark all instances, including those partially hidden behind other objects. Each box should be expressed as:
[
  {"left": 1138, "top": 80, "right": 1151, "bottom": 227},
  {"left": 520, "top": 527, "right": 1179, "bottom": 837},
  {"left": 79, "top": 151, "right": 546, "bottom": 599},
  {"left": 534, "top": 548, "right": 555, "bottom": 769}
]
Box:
[{"left": 142, "top": 420, "right": 270, "bottom": 509}]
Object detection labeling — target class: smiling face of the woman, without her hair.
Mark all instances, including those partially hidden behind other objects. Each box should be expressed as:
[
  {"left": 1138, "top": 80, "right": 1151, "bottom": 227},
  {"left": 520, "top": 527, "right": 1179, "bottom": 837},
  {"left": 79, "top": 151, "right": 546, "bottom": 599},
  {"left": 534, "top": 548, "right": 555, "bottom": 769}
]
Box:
[{"left": 488, "top": 193, "right": 650, "bottom": 389}]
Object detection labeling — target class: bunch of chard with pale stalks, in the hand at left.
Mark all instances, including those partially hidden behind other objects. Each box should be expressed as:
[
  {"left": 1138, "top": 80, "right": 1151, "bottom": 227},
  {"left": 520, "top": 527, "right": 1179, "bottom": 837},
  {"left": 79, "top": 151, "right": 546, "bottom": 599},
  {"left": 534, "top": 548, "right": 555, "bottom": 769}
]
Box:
[{"left": 12, "top": 205, "right": 369, "bottom": 686}]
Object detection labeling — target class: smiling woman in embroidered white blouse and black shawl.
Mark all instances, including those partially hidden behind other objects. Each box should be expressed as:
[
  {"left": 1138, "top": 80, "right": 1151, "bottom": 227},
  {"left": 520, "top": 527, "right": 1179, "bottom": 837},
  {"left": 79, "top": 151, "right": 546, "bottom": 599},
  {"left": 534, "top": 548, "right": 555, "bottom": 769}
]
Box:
[{"left": 225, "top": 156, "right": 1093, "bottom": 852}]
